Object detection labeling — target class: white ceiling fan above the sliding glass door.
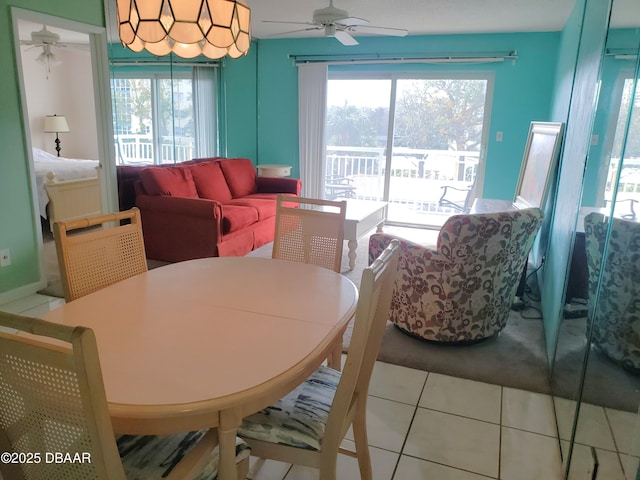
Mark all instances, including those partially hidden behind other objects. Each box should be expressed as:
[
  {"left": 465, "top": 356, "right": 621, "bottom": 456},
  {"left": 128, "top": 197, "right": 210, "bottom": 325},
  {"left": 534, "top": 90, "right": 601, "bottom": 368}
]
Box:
[{"left": 263, "top": 0, "right": 408, "bottom": 45}]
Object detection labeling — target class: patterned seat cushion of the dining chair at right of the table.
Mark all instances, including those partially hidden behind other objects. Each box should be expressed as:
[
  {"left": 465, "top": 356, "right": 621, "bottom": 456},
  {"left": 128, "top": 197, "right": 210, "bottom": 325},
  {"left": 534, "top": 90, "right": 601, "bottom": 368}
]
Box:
[{"left": 238, "top": 366, "right": 340, "bottom": 450}]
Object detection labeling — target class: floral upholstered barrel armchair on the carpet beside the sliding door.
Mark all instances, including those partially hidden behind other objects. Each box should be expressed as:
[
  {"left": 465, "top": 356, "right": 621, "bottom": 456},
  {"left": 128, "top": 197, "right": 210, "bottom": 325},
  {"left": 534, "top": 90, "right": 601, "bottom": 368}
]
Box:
[{"left": 369, "top": 208, "right": 542, "bottom": 342}]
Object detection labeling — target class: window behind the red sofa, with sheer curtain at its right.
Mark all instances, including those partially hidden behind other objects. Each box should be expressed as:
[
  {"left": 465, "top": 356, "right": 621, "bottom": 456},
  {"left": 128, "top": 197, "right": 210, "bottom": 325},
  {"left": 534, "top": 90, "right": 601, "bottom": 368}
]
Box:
[{"left": 111, "top": 67, "right": 217, "bottom": 165}]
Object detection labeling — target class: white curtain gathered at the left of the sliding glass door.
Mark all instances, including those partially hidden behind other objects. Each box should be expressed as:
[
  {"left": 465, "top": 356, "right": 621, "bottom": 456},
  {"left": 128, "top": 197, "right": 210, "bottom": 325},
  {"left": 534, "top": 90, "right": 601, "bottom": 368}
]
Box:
[{"left": 298, "top": 63, "right": 327, "bottom": 198}]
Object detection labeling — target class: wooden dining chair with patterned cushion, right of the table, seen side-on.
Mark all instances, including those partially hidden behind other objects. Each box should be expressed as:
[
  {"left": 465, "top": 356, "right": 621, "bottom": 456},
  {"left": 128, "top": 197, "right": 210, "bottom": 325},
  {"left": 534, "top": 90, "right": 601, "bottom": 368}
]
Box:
[{"left": 238, "top": 241, "right": 399, "bottom": 480}]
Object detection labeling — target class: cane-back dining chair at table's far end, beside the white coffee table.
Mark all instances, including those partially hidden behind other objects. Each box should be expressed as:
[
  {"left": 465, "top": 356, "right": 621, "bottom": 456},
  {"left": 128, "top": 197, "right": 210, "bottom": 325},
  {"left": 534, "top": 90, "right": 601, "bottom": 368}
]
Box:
[{"left": 272, "top": 195, "right": 347, "bottom": 273}]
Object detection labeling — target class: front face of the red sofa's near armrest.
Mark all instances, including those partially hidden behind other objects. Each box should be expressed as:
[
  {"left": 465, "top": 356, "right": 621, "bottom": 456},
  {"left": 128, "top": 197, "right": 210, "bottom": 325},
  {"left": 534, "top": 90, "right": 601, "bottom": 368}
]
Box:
[{"left": 136, "top": 195, "right": 222, "bottom": 262}]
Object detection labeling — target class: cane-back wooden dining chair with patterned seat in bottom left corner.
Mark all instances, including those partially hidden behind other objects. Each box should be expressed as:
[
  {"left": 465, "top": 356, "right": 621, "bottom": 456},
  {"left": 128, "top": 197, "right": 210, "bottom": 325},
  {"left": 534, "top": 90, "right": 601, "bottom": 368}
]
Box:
[{"left": 0, "top": 312, "right": 250, "bottom": 480}]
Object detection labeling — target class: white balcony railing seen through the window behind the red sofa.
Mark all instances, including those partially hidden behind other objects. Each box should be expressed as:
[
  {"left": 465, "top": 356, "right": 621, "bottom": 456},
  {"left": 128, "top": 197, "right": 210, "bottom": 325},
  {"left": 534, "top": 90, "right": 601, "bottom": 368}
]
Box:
[{"left": 115, "top": 135, "right": 195, "bottom": 165}]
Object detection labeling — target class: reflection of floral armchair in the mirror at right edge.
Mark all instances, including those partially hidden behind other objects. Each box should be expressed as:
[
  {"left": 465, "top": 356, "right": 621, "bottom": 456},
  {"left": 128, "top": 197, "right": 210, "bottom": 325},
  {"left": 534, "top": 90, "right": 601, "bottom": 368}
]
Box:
[{"left": 584, "top": 213, "right": 640, "bottom": 372}]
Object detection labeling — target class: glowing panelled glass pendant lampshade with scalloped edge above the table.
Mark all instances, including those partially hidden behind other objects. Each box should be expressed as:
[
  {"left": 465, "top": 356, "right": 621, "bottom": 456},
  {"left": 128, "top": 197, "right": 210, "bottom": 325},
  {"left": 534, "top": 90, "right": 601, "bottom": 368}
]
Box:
[{"left": 117, "top": 0, "right": 251, "bottom": 59}]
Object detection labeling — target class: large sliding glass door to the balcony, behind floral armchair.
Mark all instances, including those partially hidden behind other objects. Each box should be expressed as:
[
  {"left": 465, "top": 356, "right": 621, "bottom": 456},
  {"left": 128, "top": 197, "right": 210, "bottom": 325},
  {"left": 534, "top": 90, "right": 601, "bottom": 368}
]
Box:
[{"left": 325, "top": 75, "right": 492, "bottom": 228}]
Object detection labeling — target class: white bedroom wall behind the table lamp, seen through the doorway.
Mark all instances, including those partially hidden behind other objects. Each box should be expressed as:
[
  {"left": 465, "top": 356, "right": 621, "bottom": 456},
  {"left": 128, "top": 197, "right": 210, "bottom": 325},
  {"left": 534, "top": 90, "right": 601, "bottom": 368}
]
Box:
[{"left": 21, "top": 41, "right": 98, "bottom": 159}]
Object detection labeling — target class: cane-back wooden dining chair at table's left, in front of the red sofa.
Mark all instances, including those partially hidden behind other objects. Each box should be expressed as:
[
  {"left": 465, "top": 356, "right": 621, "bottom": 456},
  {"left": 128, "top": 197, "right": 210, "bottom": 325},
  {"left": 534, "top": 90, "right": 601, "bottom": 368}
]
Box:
[{"left": 53, "top": 207, "right": 147, "bottom": 302}]
